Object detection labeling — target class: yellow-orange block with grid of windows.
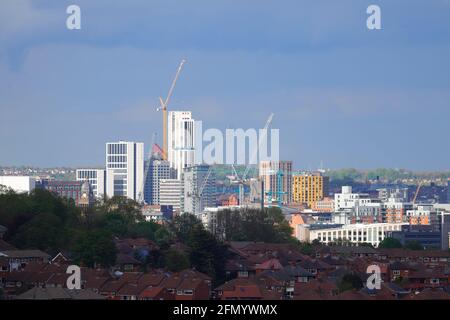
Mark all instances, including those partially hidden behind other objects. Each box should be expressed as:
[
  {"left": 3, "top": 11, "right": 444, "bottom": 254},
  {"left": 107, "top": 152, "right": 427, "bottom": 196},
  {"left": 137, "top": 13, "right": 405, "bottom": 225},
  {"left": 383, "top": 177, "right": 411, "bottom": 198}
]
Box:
[{"left": 292, "top": 172, "right": 329, "bottom": 208}]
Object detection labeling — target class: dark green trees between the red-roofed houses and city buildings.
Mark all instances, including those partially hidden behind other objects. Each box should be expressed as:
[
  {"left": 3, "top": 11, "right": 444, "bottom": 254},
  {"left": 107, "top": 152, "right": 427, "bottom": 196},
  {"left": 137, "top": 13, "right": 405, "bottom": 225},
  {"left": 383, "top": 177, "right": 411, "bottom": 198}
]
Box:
[{"left": 0, "top": 189, "right": 295, "bottom": 283}]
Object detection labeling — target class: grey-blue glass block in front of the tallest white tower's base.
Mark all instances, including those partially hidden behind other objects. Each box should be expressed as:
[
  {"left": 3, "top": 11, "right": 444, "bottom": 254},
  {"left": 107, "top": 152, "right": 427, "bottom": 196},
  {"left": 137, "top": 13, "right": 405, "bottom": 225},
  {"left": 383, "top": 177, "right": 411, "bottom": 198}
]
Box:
[{"left": 181, "top": 165, "right": 216, "bottom": 214}]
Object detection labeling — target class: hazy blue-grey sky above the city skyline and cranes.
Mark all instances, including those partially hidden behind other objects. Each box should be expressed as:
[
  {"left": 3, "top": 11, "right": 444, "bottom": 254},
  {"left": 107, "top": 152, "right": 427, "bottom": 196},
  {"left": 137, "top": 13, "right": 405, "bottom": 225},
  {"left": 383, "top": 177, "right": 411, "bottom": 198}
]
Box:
[{"left": 0, "top": 0, "right": 450, "bottom": 171}]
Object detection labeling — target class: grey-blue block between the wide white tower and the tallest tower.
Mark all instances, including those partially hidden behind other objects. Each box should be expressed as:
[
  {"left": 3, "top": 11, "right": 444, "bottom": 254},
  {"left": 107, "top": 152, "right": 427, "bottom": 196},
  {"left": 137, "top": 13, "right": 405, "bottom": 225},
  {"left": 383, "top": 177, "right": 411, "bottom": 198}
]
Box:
[{"left": 145, "top": 159, "right": 176, "bottom": 205}]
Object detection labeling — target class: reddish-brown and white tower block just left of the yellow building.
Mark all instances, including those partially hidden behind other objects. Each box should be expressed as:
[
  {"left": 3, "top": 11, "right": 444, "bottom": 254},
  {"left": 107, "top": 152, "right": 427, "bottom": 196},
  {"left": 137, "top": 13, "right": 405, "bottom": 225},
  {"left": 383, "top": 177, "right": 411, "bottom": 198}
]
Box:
[{"left": 259, "top": 161, "right": 292, "bottom": 204}]
